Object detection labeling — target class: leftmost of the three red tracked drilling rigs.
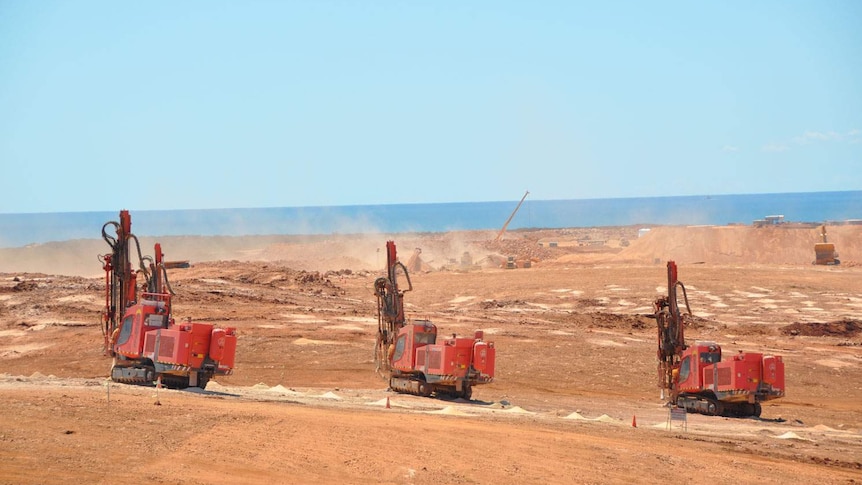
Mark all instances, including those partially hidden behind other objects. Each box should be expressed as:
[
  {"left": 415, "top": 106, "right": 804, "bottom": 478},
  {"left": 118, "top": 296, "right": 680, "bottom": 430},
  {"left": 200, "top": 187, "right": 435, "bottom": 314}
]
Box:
[{"left": 99, "top": 210, "right": 237, "bottom": 389}]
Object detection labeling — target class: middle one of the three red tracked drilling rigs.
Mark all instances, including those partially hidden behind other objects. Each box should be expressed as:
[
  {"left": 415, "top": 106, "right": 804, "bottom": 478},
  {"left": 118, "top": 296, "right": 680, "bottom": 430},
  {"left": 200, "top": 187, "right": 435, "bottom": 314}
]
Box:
[{"left": 374, "top": 241, "right": 496, "bottom": 400}]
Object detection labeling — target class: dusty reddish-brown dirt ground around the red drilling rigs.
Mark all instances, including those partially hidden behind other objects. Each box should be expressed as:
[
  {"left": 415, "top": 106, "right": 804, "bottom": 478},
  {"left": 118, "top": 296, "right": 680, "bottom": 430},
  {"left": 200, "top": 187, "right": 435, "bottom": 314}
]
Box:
[{"left": 0, "top": 226, "right": 862, "bottom": 484}]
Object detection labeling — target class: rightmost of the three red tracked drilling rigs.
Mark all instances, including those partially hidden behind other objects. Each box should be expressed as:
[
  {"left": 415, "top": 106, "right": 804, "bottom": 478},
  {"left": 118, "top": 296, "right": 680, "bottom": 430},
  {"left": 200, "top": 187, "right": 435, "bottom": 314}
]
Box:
[{"left": 654, "top": 261, "right": 784, "bottom": 417}]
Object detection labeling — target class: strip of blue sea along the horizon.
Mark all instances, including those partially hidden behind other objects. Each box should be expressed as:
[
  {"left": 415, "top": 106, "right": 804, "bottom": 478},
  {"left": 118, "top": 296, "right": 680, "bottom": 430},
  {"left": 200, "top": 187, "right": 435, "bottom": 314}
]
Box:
[{"left": 0, "top": 191, "right": 862, "bottom": 247}]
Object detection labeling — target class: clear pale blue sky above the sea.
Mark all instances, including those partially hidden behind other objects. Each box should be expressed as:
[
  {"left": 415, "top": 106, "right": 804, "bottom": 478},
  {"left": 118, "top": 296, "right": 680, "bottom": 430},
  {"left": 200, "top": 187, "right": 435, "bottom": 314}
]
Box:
[{"left": 0, "top": 0, "right": 862, "bottom": 213}]
